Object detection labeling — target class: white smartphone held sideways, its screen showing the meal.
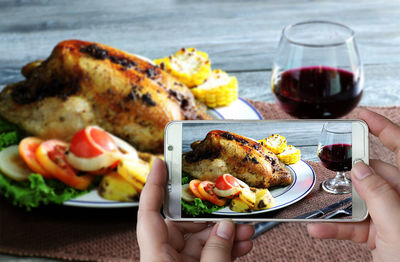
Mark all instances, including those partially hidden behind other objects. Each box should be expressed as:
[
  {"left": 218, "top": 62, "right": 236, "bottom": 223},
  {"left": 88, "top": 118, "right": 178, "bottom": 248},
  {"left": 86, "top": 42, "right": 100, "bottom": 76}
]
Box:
[{"left": 164, "top": 120, "right": 369, "bottom": 222}]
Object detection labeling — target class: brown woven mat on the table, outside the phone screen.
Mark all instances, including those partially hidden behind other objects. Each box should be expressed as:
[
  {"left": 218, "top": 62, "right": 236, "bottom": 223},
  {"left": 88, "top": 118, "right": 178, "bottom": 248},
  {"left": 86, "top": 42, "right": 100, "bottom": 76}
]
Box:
[{"left": 0, "top": 101, "right": 400, "bottom": 262}]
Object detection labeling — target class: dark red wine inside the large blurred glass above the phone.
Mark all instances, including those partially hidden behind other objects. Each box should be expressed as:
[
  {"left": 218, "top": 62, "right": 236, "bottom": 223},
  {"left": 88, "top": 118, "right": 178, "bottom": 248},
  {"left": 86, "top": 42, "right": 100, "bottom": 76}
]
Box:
[{"left": 272, "top": 67, "right": 362, "bottom": 118}]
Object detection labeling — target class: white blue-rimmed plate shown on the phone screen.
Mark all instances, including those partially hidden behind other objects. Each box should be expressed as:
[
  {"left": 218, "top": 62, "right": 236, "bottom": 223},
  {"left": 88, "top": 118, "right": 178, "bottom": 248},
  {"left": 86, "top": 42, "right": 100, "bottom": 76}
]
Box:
[{"left": 213, "top": 160, "right": 316, "bottom": 216}]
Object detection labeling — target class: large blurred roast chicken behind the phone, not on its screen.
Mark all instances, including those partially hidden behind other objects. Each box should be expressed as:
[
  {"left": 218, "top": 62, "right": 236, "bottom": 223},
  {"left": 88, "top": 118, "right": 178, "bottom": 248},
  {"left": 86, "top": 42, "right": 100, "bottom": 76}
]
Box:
[{"left": 0, "top": 40, "right": 210, "bottom": 153}]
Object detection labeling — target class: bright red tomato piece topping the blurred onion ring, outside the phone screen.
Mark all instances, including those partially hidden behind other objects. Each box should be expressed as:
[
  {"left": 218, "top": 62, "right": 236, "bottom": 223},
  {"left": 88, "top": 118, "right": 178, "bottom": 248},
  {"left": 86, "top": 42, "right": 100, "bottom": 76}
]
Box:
[{"left": 69, "top": 126, "right": 117, "bottom": 158}]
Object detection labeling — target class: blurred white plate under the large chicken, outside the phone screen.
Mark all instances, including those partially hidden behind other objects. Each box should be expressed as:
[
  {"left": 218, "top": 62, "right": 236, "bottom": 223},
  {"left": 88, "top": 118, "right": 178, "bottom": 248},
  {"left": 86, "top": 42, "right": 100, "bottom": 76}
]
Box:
[{"left": 64, "top": 98, "right": 262, "bottom": 208}]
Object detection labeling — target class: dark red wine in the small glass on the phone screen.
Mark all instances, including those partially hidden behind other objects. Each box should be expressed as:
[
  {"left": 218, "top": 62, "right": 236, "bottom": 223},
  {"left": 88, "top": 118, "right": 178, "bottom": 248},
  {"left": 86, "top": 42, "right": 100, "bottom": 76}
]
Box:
[{"left": 318, "top": 144, "right": 352, "bottom": 172}]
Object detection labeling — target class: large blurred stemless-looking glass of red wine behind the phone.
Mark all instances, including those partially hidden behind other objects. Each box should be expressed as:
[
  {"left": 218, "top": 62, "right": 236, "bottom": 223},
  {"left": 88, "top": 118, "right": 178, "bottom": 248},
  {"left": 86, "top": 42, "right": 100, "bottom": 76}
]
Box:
[{"left": 271, "top": 21, "right": 363, "bottom": 118}]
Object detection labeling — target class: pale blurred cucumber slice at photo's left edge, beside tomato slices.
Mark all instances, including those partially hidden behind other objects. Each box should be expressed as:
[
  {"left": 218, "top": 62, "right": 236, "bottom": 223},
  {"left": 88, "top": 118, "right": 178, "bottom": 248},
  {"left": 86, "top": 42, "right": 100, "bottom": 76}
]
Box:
[{"left": 0, "top": 145, "right": 32, "bottom": 181}]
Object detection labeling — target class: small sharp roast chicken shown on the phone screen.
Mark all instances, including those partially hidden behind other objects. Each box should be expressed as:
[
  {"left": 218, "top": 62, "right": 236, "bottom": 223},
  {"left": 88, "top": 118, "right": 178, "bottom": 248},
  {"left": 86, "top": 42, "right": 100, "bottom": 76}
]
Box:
[{"left": 182, "top": 130, "right": 292, "bottom": 188}]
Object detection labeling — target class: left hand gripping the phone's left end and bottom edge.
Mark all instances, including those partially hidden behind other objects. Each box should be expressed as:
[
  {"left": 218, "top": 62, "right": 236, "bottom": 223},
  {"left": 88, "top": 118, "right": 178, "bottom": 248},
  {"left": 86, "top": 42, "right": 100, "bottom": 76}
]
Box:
[{"left": 137, "top": 159, "right": 254, "bottom": 261}]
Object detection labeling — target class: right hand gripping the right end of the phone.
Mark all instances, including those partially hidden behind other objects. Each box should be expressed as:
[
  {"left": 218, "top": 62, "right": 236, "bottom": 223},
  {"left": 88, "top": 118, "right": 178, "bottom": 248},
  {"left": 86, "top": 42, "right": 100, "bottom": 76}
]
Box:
[{"left": 308, "top": 110, "right": 400, "bottom": 261}]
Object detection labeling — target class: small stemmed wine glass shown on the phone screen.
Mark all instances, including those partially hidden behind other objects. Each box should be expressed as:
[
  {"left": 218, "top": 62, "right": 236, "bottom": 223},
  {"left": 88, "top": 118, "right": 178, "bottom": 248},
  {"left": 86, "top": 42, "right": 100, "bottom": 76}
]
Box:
[{"left": 318, "top": 122, "right": 352, "bottom": 194}]
